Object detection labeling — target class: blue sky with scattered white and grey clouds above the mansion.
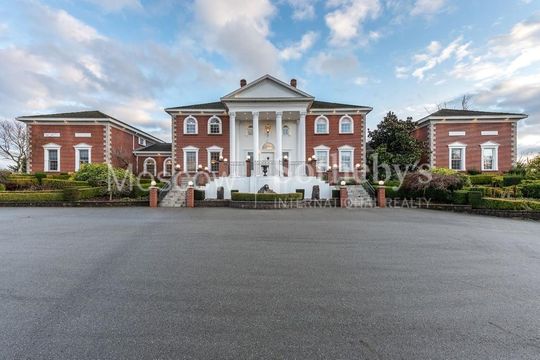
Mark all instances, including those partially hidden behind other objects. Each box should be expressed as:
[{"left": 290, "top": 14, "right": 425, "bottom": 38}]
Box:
[{"left": 0, "top": 0, "right": 540, "bottom": 167}]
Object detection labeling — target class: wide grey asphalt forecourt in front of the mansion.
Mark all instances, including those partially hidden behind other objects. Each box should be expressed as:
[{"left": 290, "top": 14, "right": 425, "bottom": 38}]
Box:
[{"left": 0, "top": 208, "right": 540, "bottom": 359}]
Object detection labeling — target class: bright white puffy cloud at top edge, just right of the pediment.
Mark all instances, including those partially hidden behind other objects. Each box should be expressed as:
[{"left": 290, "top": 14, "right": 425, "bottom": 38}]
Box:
[{"left": 325, "top": 0, "right": 381, "bottom": 46}]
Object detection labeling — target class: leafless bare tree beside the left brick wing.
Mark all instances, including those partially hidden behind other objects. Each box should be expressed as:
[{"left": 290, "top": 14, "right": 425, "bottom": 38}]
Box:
[{"left": 0, "top": 120, "right": 28, "bottom": 172}]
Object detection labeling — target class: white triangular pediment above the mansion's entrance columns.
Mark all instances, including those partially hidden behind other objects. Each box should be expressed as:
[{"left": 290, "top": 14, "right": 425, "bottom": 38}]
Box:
[{"left": 221, "top": 75, "right": 313, "bottom": 100}]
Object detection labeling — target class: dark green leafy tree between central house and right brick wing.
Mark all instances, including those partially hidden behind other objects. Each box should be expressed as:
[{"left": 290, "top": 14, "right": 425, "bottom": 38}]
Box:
[{"left": 368, "top": 111, "right": 427, "bottom": 176}]
